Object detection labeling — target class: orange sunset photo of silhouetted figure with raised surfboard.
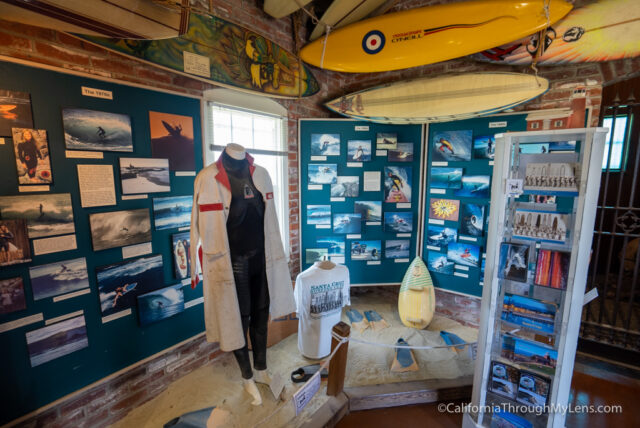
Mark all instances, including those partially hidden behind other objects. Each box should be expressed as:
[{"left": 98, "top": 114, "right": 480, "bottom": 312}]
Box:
[{"left": 149, "top": 111, "right": 196, "bottom": 171}]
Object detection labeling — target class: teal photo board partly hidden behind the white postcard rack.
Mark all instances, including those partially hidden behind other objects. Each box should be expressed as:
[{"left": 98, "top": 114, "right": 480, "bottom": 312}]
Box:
[{"left": 422, "top": 114, "right": 527, "bottom": 296}]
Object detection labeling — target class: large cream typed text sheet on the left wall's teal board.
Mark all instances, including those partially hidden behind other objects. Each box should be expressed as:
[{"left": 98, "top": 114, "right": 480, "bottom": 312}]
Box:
[{"left": 77, "top": 164, "right": 116, "bottom": 208}]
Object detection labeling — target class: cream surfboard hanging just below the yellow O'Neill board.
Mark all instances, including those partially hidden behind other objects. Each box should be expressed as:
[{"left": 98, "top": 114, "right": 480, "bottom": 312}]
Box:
[{"left": 325, "top": 73, "right": 549, "bottom": 124}]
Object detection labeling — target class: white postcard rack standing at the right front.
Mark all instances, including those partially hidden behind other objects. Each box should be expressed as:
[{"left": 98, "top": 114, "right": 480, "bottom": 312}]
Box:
[{"left": 463, "top": 128, "right": 606, "bottom": 427}]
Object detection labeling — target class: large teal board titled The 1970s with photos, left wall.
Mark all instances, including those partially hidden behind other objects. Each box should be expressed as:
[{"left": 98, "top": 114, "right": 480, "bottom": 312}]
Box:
[{"left": 0, "top": 62, "right": 204, "bottom": 425}]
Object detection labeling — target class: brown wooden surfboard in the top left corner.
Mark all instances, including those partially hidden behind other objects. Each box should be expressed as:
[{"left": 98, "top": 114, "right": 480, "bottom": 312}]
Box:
[{"left": 0, "top": 0, "right": 189, "bottom": 39}]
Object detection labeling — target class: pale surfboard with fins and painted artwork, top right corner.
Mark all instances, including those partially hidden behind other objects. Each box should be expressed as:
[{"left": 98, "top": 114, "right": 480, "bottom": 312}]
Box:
[{"left": 473, "top": 0, "right": 640, "bottom": 65}]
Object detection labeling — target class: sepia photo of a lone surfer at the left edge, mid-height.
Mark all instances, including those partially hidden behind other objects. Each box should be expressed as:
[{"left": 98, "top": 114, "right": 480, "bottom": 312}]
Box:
[{"left": 0, "top": 193, "right": 76, "bottom": 239}]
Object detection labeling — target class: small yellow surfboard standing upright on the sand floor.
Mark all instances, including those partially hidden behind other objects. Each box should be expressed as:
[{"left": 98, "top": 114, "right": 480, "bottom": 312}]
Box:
[{"left": 398, "top": 257, "right": 436, "bottom": 329}]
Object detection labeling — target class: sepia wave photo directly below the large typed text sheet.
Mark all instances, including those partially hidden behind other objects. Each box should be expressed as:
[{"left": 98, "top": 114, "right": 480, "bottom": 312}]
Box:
[{"left": 89, "top": 208, "right": 151, "bottom": 251}]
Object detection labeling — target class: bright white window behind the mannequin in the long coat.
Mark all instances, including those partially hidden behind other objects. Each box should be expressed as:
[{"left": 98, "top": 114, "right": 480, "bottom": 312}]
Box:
[{"left": 205, "top": 102, "right": 289, "bottom": 254}]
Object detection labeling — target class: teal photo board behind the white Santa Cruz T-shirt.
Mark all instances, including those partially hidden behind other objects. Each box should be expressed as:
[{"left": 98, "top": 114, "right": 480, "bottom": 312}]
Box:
[{"left": 299, "top": 119, "right": 423, "bottom": 285}]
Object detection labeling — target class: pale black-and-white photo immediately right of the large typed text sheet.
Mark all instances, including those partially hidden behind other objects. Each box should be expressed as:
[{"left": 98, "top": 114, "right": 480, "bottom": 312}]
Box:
[{"left": 120, "top": 158, "right": 171, "bottom": 195}]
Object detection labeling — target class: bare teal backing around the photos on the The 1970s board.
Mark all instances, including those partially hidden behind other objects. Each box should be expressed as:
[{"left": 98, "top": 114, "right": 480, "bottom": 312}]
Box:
[{"left": 0, "top": 62, "right": 204, "bottom": 425}]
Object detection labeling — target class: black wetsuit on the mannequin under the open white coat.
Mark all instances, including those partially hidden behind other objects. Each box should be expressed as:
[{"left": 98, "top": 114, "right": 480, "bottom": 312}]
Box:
[{"left": 222, "top": 152, "right": 269, "bottom": 379}]
